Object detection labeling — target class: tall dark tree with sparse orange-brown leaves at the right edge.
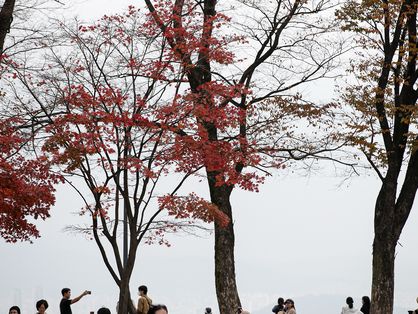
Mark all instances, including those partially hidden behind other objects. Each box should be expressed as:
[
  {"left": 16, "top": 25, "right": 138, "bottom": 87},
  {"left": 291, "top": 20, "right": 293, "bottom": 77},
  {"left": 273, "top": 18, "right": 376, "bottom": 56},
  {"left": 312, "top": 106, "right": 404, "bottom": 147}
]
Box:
[{"left": 340, "top": 0, "right": 418, "bottom": 314}]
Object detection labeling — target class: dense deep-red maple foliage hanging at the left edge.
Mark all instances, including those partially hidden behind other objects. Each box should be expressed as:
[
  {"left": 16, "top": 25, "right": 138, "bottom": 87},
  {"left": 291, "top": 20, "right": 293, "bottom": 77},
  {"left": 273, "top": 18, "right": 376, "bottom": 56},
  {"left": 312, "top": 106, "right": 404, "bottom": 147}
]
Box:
[{"left": 0, "top": 119, "right": 60, "bottom": 242}]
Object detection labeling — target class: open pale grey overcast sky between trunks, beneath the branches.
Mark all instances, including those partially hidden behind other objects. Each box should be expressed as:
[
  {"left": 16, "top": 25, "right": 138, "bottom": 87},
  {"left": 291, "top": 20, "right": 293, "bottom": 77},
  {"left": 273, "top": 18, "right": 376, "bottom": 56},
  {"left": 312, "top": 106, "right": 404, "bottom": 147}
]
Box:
[{"left": 0, "top": 0, "right": 418, "bottom": 314}]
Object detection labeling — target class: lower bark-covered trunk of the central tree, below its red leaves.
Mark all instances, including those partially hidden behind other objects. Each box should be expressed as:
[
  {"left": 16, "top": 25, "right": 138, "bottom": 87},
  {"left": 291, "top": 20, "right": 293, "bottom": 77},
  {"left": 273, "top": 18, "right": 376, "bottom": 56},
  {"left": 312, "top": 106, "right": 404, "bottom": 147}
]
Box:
[{"left": 208, "top": 174, "right": 241, "bottom": 314}]
